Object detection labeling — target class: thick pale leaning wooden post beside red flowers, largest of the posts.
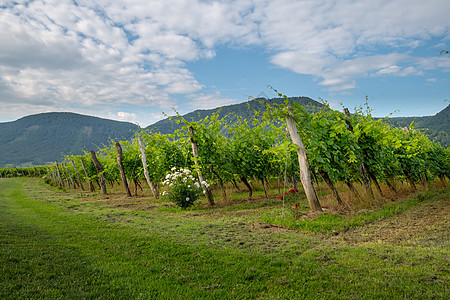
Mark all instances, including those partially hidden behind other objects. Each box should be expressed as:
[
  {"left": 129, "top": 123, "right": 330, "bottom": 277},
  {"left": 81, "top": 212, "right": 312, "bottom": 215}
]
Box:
[{"left": 286, "top": 105, "right": 322, "bottom": 212}]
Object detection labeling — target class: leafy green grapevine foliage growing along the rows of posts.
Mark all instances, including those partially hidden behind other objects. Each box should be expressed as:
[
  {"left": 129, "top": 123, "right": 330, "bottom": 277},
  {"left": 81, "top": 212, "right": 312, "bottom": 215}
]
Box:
[{"left": 10, "top": 88, "right": 450, "bottom": 213}]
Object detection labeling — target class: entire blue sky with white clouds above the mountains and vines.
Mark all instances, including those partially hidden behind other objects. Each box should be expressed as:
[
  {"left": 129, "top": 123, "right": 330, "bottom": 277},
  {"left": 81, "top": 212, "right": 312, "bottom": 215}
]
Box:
[{"left": 0, "top": 0, "right": 450, "bottom": 127}]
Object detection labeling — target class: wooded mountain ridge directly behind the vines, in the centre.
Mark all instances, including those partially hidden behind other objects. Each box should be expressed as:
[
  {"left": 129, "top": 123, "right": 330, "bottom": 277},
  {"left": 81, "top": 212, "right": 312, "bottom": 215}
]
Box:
[{"left": 146, "top": 97, "right": 324, "bottom": 134}]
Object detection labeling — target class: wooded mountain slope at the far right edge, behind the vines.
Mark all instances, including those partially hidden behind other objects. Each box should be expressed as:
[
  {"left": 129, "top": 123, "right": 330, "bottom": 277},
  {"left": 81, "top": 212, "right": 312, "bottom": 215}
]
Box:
[{"left": 386, "top": 105, "right": 450, "bottom": 148}]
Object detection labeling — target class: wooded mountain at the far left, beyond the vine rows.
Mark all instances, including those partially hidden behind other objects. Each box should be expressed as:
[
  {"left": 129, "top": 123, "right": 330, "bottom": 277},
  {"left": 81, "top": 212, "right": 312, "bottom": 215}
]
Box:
[{"left": 0, "top": 112, "right": 139, "bottom": 166}]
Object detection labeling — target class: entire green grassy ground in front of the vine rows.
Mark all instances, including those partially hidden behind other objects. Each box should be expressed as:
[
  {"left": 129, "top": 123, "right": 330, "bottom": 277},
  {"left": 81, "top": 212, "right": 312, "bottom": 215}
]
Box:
[{"left": 0, "top": 178, "right": 450, "bottom": 299}]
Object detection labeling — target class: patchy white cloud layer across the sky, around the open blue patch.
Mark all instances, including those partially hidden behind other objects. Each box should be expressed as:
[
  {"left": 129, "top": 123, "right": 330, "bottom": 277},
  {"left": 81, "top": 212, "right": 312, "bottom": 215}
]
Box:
[{"left": 0, "top": 0, "right": 450, "bottom": 118}]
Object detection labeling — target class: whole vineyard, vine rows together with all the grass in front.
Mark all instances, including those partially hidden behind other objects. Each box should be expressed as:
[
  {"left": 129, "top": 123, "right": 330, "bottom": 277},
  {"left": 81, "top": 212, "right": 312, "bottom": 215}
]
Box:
[{"left": 0, "top": 95, "right": 450, "bottom": 299}]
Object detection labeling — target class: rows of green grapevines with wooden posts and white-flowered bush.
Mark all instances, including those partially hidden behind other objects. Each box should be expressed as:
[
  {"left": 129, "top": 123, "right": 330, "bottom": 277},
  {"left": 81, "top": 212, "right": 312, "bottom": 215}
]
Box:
[{"left": 0, "top": 94, "right": 450, "bottom": 217}]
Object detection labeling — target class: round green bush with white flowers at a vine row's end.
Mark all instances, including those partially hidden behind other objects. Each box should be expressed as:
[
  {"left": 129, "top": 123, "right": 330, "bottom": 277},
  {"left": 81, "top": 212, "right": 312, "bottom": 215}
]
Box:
[{"left": 162, "top": 167, "right": 209, "bottom": 208}]
